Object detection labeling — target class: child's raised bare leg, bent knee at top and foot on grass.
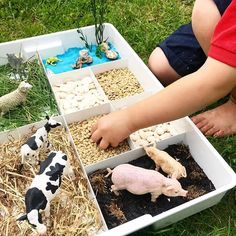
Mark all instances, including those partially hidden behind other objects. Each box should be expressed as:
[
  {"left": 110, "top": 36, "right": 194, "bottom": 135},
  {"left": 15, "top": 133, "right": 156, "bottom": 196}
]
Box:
[{"left": 192, "top": 0, "right": 236, "bottom": 137}]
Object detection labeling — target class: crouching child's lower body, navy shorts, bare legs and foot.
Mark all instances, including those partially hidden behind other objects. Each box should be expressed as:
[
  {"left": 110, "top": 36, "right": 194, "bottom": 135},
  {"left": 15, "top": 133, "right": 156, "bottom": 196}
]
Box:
[{"left": 149, "top": 0, "right": 236, "bottom": 136}]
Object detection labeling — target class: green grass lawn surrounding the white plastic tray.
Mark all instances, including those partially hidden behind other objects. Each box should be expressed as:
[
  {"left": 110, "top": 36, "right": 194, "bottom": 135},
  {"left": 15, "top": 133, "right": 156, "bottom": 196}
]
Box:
[{"left": 0, "top": 0, "right": 236, "bottom": 236}]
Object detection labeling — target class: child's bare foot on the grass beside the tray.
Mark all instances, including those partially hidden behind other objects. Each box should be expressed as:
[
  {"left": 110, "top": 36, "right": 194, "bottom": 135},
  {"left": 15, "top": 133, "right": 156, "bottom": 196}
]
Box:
[{"left": 192, "top": 100, "right": 236, "bottom": 137}]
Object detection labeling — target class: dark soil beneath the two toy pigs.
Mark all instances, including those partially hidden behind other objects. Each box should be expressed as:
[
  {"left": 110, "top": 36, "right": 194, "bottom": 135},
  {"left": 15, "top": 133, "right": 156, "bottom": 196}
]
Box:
[{"left": 89, "top": 144, "right": 215, "bottom": 229}]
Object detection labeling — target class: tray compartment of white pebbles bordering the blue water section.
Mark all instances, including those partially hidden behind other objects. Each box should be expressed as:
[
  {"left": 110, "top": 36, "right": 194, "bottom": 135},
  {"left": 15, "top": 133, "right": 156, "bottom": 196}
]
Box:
[{"left": 46, "top": 68, "right": 108, "bottom": 114}]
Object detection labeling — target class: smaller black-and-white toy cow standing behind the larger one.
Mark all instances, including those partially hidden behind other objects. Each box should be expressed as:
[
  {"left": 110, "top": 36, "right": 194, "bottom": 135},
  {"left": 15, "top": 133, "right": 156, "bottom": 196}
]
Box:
[{"left": 20, "top": 116, "right": 61, "bottom": 165}]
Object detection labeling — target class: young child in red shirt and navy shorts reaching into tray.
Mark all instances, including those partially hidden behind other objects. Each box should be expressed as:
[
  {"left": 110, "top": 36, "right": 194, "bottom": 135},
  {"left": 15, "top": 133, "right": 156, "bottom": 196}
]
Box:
[{"left": 91, "top": 0, "right": 236, "bottom": 149}]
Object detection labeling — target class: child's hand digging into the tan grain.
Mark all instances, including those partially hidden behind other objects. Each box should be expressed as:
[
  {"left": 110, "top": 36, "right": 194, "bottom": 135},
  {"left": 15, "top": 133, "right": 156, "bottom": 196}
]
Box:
[{"left": 91, "top": 110, "right": 133, "bottom": 149}]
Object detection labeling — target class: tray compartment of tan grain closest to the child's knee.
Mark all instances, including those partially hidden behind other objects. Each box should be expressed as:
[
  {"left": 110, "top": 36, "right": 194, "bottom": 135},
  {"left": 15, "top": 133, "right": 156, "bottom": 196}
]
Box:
[{"left": 91, "top": 59, "right": 162, "bottom": 101}]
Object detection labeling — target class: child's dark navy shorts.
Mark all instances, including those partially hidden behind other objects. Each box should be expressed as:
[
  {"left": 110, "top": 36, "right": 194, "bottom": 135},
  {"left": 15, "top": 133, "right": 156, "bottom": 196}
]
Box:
[{"left": 158, "top": 0, "right": 231, "bottom": 76}]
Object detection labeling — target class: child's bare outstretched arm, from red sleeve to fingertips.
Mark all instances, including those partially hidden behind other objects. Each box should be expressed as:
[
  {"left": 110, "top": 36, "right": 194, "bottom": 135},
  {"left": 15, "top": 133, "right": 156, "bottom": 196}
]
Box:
[{"left": 91, "top": 57, "right": 236, "bottom": 149}]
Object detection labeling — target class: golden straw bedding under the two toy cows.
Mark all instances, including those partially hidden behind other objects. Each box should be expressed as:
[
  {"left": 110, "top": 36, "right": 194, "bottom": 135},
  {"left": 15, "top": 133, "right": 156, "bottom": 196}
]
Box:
[{"left": 0, "top": 126, "right": 102, "bottom": 236}]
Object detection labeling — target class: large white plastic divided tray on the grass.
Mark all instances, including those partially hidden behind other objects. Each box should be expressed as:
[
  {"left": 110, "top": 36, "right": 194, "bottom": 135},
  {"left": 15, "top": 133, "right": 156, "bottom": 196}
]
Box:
[{"left": 0, "top": 24, "right": 236, "bottom": 235}]
